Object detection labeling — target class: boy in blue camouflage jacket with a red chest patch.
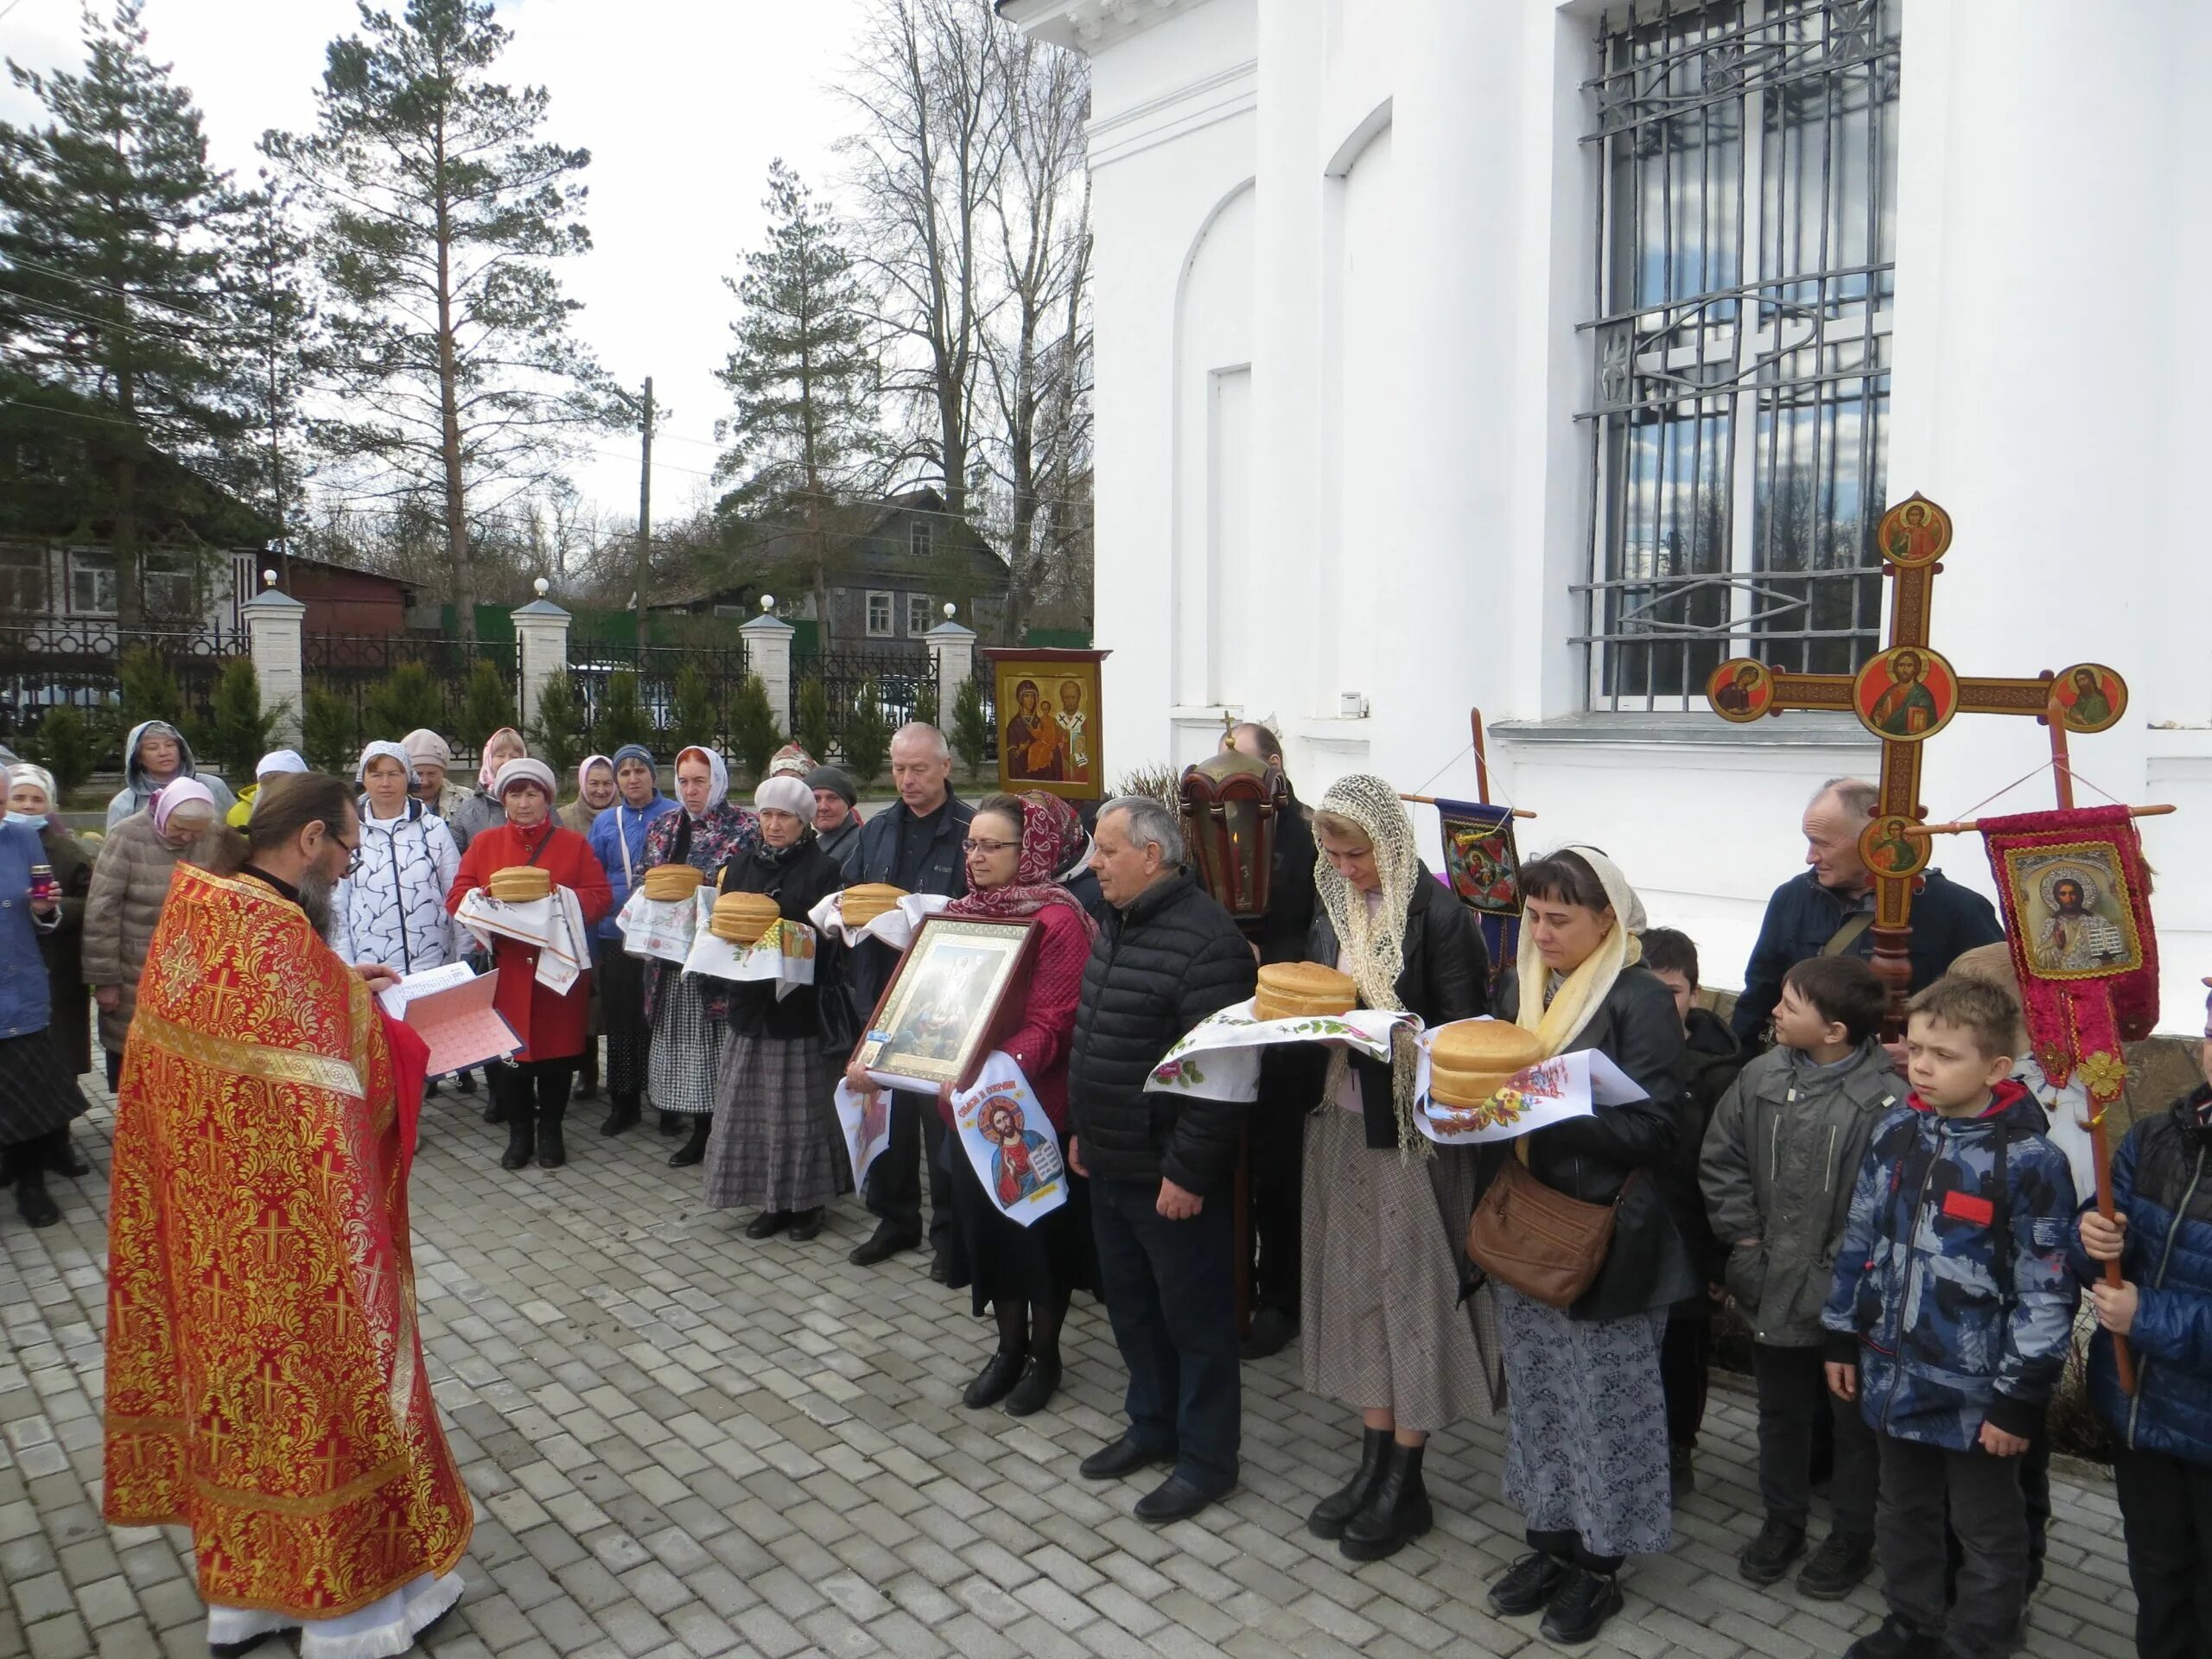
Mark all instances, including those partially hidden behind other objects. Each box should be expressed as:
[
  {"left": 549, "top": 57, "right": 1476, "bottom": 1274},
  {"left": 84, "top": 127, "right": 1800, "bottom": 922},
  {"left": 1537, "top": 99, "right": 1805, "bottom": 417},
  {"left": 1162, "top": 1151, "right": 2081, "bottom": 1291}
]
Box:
[{"left": 1821, "top": 978, "right": 2077, "bottom": 1659}]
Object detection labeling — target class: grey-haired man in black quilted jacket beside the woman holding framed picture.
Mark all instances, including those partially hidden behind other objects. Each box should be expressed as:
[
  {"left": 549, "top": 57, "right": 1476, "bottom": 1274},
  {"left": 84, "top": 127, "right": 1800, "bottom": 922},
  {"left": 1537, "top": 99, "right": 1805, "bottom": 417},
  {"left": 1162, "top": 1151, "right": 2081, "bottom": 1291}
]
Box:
[{"left": 1068, "top": 797, "right": 1256, "bottom": 1522}]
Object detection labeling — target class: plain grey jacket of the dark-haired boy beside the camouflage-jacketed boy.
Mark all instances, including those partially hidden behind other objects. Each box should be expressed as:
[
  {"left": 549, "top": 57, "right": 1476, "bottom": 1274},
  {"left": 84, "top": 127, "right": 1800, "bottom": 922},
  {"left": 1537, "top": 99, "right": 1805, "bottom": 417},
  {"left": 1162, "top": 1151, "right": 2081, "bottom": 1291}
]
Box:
[{"left": 1699, "top": 1038, "right": 1904, "bottom": 1347}]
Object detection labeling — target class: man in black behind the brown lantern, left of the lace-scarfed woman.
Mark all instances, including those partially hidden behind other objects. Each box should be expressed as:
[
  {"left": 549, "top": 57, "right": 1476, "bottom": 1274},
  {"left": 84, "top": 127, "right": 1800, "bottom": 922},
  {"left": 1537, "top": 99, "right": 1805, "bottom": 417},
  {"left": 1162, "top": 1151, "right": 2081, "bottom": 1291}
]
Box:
[{"left": 1230, "top": 721, "right": 1323, "bottom": 1360}]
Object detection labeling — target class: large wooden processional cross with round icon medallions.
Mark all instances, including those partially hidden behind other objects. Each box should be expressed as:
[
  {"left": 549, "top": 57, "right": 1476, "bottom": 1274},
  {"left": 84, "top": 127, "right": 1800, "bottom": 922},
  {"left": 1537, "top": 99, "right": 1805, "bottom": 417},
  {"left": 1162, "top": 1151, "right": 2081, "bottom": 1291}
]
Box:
[{"left": 1706, "top": 495, "right": 2128, "bottom": 1039}]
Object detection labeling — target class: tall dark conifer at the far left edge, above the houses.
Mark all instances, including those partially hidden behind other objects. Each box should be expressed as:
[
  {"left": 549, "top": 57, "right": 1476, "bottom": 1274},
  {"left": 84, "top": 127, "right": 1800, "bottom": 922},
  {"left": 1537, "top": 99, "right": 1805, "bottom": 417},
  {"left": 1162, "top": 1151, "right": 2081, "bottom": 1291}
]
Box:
[{"left": 0, "top": 0, "right": 244, "bottom": 635}]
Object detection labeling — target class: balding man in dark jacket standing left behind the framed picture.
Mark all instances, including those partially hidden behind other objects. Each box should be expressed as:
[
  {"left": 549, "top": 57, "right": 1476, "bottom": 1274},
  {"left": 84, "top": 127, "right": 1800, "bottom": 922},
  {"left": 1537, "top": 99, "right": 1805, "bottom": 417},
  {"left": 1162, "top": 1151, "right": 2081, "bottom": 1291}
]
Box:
[{"left": 845, "top": 721, "right": 976, "bottom": 1283}]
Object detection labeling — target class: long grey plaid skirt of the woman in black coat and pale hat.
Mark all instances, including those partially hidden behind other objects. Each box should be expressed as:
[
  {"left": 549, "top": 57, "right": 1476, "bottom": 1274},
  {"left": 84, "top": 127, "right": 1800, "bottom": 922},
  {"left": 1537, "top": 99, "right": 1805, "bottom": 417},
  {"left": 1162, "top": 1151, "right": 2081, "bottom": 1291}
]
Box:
[{"left": 706, "top": 1035, "right": 852, "bottom": 1210}]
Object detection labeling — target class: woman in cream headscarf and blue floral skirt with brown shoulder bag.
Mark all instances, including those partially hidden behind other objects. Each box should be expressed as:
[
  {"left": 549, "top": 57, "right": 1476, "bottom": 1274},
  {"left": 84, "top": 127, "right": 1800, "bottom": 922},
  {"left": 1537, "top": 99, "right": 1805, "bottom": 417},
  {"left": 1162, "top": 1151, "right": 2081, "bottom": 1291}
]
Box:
[{"left": 1486, "top": 847, "right": 1699, "bottom": 1643}]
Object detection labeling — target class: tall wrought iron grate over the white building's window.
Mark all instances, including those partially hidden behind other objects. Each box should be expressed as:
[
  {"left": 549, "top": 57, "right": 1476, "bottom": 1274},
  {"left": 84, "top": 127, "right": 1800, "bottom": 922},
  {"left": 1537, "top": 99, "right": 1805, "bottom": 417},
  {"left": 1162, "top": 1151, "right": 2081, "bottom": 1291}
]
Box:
[{"left": 1573, "top": 0, "right": 1900, "bottom": 710}]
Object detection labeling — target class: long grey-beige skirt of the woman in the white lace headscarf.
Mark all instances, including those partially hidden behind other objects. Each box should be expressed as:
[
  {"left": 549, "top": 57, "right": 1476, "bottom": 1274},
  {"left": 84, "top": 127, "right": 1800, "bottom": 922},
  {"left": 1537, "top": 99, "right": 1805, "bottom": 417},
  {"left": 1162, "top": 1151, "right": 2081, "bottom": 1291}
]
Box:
[{"left": 1299, "top": 1106, "right": 1497, "bottom": 1433}]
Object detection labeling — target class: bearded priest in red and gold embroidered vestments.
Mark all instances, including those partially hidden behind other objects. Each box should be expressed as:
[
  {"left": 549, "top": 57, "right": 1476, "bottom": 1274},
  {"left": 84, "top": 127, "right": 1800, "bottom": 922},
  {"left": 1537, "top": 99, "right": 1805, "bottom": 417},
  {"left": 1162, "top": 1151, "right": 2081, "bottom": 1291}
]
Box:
[{"left": 106, "top": 772, "right": 471, "bottom": 1659}]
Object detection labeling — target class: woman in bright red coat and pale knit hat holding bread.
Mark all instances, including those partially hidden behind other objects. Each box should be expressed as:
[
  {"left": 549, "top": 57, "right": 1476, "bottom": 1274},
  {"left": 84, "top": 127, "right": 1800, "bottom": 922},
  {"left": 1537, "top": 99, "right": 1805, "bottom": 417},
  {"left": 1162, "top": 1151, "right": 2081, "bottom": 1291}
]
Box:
[{"left": 445, "top": 759, "right": 615, "bottom": 1170}]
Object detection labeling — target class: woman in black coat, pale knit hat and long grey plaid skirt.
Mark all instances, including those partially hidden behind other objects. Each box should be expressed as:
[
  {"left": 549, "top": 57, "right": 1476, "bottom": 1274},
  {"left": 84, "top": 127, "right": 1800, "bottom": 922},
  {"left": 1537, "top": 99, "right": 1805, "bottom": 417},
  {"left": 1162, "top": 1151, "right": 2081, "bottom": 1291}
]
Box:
[{"left": 706, "top": 777, "right": 852, "bottom": 1243}]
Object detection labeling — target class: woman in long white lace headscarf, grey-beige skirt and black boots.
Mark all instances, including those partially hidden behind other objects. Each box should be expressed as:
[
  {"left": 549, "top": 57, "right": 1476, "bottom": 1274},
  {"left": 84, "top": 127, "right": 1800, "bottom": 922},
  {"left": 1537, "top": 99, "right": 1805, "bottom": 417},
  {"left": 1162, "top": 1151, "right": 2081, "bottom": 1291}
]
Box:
[{"left": 1299, "top": 774, "right": 1497, "bottom": 1561}]
